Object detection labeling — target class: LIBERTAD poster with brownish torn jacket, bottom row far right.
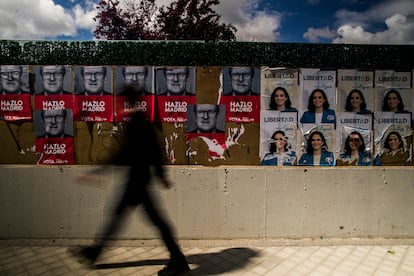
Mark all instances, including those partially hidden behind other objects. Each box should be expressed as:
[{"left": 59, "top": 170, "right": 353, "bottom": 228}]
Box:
[{"left": 374, "top": 112, "right": 413, "bottom": 166}]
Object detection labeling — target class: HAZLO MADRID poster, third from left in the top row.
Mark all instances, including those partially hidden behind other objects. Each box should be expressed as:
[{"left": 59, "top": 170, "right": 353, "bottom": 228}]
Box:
[{"left": 74, "top": 66, "right": 114, "bottom": 122}]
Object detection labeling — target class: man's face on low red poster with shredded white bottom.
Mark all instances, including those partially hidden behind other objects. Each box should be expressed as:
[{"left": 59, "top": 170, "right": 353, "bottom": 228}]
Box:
[{"left": 194, "top": 104, "right": 219, "bottom": 132}]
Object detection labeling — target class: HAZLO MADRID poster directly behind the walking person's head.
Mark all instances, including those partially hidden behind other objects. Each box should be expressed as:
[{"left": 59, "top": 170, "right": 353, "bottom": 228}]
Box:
[{"left": 115, "top": 66, "right": 155, "bottom": 123}]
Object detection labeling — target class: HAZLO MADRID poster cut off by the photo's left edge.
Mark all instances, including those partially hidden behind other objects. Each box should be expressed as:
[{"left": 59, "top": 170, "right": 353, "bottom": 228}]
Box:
[{"left": 0, "top": 65, "right": 32, "bottom": 121}]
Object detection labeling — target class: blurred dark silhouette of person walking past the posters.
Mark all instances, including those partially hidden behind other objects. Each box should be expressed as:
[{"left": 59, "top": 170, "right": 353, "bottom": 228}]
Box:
[{"left": 77, "top": 86, "right": 190, "bottom": 275}]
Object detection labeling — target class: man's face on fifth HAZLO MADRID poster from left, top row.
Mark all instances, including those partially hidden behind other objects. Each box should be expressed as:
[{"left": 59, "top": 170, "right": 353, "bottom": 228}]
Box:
[{"left": 164, "top": 67, "right": 190, "bottom": 96}]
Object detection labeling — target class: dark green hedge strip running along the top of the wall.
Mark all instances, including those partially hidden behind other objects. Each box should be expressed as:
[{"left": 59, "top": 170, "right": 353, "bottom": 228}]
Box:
[{"left": 0, "top": 40, "right": 414, "bottom": 70}]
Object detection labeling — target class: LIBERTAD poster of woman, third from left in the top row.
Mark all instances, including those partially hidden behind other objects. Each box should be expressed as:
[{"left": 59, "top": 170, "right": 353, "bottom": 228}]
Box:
[{"left": 336, "top": 69, "right": 375, "bottom": 114}]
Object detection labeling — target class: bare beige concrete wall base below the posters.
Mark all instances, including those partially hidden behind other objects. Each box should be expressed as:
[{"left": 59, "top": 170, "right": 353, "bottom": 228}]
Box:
[{"left": 0, "top": 166, "right": 414, "bottom": 239}]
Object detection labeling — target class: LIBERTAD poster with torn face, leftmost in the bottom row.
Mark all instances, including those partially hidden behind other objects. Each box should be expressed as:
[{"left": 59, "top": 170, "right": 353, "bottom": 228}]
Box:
[{"left": 259, "top": 110, "right": 298, "bottom": 166}]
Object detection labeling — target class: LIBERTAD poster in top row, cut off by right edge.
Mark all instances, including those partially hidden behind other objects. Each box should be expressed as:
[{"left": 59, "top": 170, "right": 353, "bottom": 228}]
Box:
[{"left": 375, "top": 70, "right": 414, "bottom": 113}]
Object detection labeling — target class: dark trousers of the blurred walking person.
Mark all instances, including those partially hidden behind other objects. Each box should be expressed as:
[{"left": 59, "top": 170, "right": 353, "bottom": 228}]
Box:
[{"left": 96, "top": 180, "right": 184, "bottom": 259}]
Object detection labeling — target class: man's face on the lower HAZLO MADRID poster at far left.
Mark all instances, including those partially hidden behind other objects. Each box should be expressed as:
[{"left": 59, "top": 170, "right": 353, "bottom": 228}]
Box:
[{"left": 41, "top": 109, "right": 66, "bottom": 137}]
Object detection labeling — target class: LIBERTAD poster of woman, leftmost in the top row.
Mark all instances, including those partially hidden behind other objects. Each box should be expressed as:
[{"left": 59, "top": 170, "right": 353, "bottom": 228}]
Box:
[{"left": 260, "top": 67, "right": 299, "bottom": 111}]
